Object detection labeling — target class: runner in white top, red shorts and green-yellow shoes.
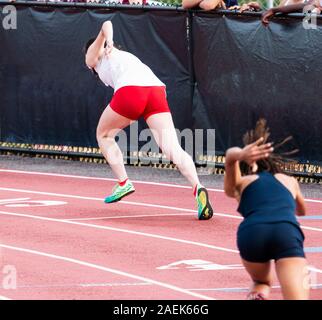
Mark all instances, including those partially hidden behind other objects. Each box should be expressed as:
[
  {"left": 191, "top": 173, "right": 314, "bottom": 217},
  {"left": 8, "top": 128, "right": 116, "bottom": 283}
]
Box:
[{"left": 86, "top": 21, "right": 213, "bottom": 220}]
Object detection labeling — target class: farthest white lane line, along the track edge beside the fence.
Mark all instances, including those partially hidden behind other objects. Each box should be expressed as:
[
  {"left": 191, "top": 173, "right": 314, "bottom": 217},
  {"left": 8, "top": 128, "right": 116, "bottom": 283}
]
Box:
[{"left": 0, "top": 169, "right": 322, "bottom": 203}]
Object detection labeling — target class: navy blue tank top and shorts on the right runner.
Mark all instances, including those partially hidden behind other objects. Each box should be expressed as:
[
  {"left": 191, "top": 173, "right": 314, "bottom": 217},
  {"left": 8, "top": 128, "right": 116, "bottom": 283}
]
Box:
[{"left": 237, "top": 172, "right": 305, "bottom": 262}]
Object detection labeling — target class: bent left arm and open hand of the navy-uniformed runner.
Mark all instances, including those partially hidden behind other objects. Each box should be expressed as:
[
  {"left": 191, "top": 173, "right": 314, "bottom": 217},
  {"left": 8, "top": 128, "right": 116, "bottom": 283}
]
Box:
[{"left": 224, "top": 138, "right": 273, "bottom": 198}]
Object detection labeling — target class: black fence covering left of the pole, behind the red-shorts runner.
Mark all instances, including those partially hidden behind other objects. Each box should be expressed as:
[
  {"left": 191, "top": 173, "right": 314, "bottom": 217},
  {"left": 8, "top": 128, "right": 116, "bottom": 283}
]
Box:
[{"left": 0, "top": 5, "right": 191, "bottom": 151}]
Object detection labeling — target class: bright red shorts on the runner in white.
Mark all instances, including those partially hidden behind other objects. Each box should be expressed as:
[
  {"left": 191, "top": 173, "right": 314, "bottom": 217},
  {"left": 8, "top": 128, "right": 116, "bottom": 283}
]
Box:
[{"left": 110, "top": 86, "right": 170, "bottom": 120}]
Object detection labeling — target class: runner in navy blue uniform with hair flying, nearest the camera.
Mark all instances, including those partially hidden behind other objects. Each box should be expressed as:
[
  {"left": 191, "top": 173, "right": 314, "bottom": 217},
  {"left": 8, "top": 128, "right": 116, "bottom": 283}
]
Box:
[{"left": 225, "top": 119, "right": 309, "bottom": 300}]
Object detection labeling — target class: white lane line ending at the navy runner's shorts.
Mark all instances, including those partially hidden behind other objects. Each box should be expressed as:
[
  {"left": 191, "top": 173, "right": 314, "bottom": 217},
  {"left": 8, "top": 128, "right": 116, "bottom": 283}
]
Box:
[{"left": 0, "top": 211, "right": 239, "bottom": 253}]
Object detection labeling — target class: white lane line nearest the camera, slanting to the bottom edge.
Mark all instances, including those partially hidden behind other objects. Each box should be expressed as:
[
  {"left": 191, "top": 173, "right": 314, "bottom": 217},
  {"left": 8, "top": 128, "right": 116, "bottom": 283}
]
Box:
[{"left": 0, "top": 244, "right": 214, "bottom": 300}]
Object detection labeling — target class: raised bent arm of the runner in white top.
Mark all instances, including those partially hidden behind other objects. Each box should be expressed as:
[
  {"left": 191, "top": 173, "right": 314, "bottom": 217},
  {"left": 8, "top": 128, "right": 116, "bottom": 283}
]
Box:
[{"left": 85, "top": 21, "right": 113, "bottom": 68}]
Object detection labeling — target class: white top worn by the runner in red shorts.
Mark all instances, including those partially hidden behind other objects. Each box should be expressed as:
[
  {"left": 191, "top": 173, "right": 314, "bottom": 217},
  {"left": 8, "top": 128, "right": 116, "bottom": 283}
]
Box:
[{"left": 95, "top": 48, "right": 165, "bottom": 91}]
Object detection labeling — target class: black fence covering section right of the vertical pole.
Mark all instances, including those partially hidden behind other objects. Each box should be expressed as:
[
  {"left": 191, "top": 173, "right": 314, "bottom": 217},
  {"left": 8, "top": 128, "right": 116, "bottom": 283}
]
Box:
[{"left": 193, "top": 12, "right": 322, "bottom": 161}]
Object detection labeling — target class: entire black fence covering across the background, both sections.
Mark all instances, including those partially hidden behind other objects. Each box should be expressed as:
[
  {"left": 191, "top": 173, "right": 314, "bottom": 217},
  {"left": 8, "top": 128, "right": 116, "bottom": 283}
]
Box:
[{"left": 0, "top": 1, "right": 322, "bottom": 162}]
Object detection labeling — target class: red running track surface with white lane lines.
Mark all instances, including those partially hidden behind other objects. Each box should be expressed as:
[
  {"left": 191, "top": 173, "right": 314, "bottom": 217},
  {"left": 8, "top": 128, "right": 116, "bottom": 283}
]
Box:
[{"left": 0, "top": 170, "right": 322, "bottom": 300}]
